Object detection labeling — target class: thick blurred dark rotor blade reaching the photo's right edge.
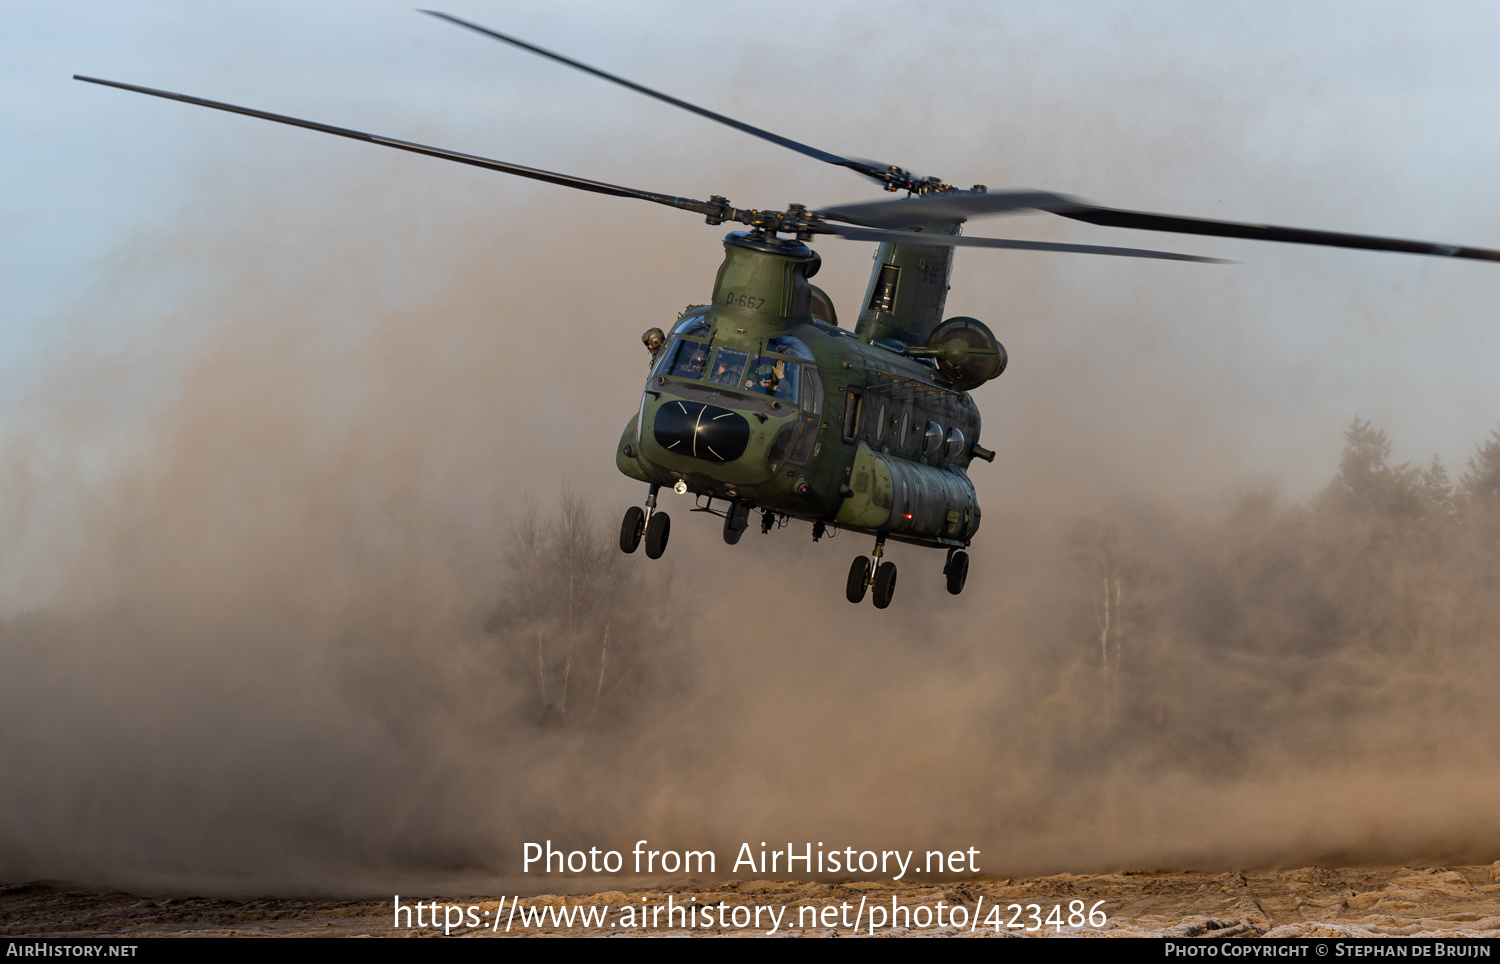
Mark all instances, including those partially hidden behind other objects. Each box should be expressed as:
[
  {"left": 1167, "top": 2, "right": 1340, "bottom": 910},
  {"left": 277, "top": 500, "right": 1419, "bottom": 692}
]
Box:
[{"left": 821, "top": 190, "right": 1500, "bottom": 261}]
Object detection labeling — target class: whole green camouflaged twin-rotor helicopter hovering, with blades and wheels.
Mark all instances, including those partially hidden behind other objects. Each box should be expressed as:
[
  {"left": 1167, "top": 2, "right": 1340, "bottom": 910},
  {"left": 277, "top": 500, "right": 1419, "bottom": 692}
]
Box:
[{"left": 74, "top": 10, "right": 1500, "bottom": 609}]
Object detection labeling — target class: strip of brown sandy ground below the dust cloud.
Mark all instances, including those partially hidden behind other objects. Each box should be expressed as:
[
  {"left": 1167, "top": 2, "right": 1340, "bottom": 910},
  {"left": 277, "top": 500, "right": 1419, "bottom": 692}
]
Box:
[{"left": 0, "top": 861, "right": 1500, "bottom": 937}]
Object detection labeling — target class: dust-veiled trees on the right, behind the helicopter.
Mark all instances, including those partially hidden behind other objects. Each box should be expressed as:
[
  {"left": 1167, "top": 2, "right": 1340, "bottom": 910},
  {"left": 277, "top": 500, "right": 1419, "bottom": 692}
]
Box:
[{"left": 1068, "top": 418, "right": 1500, "bottom": 756}]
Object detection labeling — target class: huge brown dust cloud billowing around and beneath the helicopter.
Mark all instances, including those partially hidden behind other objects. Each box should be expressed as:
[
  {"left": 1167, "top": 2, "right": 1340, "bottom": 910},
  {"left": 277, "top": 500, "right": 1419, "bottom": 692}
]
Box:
[{"left": 0, "top": 131, "right": 1500, "bottom": 892}]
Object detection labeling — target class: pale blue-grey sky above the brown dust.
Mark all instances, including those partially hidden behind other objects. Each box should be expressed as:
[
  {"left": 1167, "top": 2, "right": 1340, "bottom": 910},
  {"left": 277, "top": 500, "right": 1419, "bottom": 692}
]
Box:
[{"left": 0, "top": 3, "right": 1500, "bottom": 495}]
